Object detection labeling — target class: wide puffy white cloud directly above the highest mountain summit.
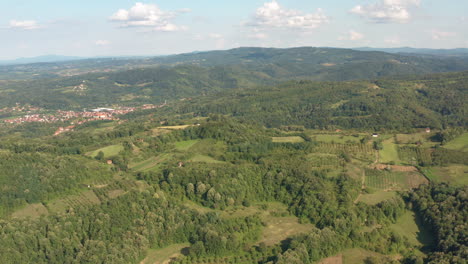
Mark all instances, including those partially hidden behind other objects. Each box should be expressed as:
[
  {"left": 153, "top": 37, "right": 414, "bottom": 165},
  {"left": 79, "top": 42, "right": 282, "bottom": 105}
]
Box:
[{"left": 247, "top": 0, "right": 328, "bottom": 29}]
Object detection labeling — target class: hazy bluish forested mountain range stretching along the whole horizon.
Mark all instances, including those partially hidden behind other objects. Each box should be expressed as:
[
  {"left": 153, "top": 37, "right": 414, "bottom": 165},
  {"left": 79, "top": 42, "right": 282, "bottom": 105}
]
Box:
[{"left": 0, "top": 47, "right": 468, "bottom": 81}]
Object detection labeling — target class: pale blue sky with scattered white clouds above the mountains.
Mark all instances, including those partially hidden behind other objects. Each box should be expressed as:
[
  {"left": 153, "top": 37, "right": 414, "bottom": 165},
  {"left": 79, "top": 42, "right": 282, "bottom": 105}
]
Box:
[{"left": 0, "top": 0, "right": 468, "bottom": 59}]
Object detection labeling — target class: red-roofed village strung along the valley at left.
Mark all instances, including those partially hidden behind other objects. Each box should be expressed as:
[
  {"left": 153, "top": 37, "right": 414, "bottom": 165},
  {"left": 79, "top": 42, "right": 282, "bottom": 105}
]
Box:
[{"left": 0, "top": 102, "right": 167, "bottom": 136}]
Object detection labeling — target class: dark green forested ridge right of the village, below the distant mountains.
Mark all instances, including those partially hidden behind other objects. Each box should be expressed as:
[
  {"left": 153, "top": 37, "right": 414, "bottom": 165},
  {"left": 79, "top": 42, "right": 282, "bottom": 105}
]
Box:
[{"left": 173, "top": 72, "right": 468, "bottom": 130}]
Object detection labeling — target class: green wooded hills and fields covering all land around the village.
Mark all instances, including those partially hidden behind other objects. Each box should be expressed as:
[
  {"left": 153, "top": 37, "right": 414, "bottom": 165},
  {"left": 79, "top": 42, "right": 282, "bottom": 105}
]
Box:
[{"left": 0, "top": 48, "right": 468, "bottom": 264}]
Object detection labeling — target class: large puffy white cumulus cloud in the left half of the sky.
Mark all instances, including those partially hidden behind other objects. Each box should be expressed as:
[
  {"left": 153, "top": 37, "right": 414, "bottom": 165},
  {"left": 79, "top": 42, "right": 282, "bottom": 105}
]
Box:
[{"left": 109, "top": 3, "right": 190, "bottom": 31}]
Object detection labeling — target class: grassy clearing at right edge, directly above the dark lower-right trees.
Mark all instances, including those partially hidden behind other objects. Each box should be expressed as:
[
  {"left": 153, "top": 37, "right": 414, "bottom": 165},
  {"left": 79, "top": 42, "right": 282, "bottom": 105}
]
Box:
[{"left": 423, "top": 165, "right": 468, "bottom": 186}]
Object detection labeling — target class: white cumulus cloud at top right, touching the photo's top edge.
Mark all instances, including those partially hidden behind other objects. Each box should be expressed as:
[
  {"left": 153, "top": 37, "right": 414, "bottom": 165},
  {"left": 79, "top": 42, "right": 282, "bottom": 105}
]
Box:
[{"left": 350, "top": 0, "right": 421, "bottom": 23}]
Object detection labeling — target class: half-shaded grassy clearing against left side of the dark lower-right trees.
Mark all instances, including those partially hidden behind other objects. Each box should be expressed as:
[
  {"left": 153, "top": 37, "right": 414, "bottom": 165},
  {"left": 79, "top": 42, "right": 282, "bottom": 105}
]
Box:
[{"left": 391, "top": 211, "right": 434, "bottom": 246}]
